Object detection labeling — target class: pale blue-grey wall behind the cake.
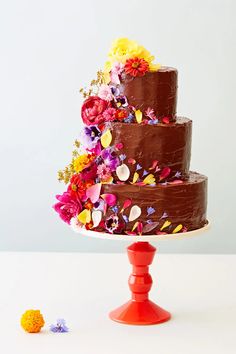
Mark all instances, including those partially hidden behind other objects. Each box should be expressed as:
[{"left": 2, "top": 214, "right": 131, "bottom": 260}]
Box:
[{"left": 0, "top": 0, "right": 236, "bottom": 253}]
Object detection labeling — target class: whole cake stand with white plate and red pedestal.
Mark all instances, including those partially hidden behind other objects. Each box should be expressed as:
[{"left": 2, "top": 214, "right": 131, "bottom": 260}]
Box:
[{"left": 76, "top": 223, "right": 209, "bottom": 325}]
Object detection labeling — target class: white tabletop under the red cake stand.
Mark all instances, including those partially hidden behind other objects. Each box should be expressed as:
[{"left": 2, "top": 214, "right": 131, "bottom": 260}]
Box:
[{"left": 0, "top": 253, "right": 236, "bottom": 354}]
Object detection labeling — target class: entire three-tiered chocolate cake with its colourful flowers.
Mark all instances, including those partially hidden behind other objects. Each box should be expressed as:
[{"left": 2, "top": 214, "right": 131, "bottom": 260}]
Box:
[{"left": 54, "top": 38, "right": 207, "bottom": 235}]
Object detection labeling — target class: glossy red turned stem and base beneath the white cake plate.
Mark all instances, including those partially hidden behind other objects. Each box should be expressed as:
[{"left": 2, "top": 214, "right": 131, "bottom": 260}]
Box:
[{"left": 110, "top": 242, "right": 171, "bottom": 325}]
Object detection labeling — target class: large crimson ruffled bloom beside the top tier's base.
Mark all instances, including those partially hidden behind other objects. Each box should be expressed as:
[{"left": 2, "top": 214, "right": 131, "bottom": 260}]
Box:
[{"left": 81, "top": 96, "right": 109, "bottom": 125}]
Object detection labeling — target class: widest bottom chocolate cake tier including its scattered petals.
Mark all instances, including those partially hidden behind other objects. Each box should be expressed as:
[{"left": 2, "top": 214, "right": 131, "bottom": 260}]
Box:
[{"left": 102, "top": 172, "right": 207, "bottom": 234}]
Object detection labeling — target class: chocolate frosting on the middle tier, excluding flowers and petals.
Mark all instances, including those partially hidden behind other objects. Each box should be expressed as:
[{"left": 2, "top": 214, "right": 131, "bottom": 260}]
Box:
[{"left": 111, "top": 117, "right": 192, "bottom": 181}]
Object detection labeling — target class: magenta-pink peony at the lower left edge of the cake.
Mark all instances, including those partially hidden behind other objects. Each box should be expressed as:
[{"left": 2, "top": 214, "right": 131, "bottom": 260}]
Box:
[{"left": 53, "top": 192, "right": 82, "bottom": 224}]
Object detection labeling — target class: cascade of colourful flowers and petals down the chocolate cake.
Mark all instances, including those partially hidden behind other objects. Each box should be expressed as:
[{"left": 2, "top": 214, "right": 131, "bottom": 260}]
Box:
[{"left": 53, "top": 38, "right": 186, "bottom": 234}]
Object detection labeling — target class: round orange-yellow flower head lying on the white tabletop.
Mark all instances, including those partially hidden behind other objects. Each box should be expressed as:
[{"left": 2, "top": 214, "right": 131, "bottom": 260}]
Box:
[{"left": 21, "top": 310, "right": 45, "bottom": 333}]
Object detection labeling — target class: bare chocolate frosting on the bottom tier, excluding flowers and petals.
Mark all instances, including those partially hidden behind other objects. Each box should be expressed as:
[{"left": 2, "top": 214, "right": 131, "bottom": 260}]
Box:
[{"left": 102, "top": 172, "right": 207, "bottom": 234}]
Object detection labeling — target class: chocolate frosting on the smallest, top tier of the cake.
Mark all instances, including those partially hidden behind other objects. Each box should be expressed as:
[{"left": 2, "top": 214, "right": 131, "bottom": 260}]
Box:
[{"left": 120, "top": 66, "right": 178, "bottom": 121}]
